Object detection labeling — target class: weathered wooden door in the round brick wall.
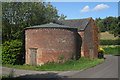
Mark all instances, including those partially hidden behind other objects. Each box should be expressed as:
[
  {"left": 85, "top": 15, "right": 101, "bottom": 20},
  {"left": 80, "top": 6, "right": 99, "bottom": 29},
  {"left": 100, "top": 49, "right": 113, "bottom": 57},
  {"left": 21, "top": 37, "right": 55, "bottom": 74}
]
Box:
[{"left": 30, "top": 48, "right": 37, "bottom": 65}]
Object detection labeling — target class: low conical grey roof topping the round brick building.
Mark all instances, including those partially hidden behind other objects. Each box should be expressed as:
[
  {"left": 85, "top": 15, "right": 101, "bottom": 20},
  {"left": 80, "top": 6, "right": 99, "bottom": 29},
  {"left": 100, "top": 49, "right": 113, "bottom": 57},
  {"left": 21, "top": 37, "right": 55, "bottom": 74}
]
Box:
[{"left": 25, "top": 23, "right": 77, "bottom": 31}]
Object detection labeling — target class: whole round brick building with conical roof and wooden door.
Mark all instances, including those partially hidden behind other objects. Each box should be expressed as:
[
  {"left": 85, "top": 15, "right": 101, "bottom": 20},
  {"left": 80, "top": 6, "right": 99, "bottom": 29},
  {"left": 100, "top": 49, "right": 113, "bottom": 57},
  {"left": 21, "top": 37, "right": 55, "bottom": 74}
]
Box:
[{"left": 25, "top": 23, "right": 80, "bottom": 65}]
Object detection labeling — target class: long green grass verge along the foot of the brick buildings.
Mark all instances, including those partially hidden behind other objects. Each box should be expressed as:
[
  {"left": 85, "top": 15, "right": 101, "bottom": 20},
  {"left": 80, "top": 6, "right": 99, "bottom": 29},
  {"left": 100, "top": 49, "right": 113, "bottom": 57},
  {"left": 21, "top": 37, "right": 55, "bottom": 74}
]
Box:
[{"left": 3, "top": 57, "right": 104, "bottom": 71}]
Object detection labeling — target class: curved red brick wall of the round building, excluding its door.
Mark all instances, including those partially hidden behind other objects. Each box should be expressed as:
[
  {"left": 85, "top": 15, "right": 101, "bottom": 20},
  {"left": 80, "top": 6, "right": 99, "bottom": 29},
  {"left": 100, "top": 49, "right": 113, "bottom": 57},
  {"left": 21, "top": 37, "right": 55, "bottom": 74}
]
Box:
[{"left": 25, "top": 28, "right": 77, "bottom": 65}]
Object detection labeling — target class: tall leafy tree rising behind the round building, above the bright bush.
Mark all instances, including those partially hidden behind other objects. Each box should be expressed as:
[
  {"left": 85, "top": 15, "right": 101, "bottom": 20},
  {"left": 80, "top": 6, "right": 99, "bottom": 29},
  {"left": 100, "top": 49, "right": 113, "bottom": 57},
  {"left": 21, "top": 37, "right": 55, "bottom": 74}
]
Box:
[{"left": 2, "top": 2, "right": 66, "bottom": 42}]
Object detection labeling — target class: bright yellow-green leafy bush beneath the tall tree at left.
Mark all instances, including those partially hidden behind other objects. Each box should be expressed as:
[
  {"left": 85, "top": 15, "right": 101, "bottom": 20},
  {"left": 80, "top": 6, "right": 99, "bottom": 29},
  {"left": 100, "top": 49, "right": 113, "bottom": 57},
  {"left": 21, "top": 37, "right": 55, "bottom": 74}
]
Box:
[{"left": 2, "top": 40, "right": 22, "bottom": 64}]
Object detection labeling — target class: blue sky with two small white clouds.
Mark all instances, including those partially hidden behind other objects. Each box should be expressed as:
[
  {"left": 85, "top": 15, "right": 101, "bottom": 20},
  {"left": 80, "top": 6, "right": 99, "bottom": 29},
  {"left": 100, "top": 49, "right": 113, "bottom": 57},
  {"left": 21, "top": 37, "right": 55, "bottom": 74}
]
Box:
[{"left": 51, "top": 2, "right": 118, "bottom": 19}]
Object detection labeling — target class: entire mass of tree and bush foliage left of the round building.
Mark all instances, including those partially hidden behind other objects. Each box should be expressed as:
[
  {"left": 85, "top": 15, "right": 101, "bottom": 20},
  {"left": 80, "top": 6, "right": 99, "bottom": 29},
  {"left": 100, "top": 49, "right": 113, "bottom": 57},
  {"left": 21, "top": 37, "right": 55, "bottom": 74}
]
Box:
[{"left": 2, "top": 2, "right": 66, "bottom": 64}]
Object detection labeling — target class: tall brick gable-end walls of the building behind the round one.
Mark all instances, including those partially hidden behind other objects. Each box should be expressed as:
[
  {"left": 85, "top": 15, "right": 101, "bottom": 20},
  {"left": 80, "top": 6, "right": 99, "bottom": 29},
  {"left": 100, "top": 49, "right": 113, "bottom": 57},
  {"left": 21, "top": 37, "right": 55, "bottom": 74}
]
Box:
[{"left": 78, "top": 18, "right": 100, "bottom": 58}]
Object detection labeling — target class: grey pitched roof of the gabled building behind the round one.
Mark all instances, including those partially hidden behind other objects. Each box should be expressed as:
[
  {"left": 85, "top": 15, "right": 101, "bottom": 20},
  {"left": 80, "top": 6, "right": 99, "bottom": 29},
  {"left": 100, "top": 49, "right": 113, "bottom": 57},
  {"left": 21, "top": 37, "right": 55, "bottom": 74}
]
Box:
[{"left": 56, "top": 18, "right": 91, "bottom": 31}]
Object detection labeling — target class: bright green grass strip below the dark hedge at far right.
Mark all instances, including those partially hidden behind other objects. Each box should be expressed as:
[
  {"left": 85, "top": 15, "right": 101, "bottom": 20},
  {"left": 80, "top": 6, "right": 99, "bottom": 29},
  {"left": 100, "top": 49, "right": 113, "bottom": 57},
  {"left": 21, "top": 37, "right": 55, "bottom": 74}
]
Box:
[{"left": 102, "top": 46, "right": 120, "bottom": 54}]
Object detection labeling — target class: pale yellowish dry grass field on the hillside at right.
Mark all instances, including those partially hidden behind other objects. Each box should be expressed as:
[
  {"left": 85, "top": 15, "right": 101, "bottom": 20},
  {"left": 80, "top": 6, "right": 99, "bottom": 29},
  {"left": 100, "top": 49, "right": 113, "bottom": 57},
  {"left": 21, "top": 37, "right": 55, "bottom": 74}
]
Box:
[{"left": 100, "top": 31, "right": 118, "bottom": 40}]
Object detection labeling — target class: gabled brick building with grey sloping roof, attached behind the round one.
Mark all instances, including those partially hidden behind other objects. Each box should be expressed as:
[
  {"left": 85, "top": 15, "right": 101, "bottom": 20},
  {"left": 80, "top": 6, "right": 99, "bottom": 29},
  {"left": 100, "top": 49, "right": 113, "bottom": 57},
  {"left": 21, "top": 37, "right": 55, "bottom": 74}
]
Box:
[{"left": 55, "top": 18, "right": 99, "bottom": 58}]
